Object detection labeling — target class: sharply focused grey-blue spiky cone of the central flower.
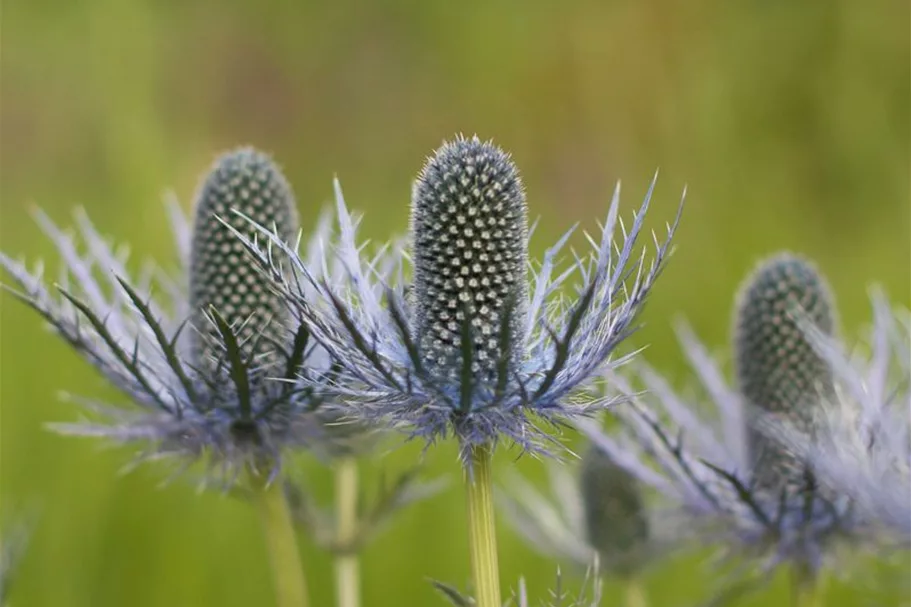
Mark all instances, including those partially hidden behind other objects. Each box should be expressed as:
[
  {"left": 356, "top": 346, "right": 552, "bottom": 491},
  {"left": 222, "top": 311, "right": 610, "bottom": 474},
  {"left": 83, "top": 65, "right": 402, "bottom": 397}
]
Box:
[{"left": 411, "top": 137, "right": 528, "bottom": 382}]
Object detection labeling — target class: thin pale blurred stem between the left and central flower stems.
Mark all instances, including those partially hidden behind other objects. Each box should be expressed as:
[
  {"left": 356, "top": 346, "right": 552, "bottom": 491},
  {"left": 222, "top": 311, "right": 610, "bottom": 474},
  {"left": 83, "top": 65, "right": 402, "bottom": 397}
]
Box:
[{"left": 335, "top": 457, "right": 361, "bottom": 607}]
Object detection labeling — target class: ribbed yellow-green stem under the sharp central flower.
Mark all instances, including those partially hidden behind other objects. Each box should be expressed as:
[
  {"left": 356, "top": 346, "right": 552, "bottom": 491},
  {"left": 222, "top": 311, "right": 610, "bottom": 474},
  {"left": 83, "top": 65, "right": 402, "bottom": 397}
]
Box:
[{"left": 465, "top": 446, "right": 501, "bottom": 607}]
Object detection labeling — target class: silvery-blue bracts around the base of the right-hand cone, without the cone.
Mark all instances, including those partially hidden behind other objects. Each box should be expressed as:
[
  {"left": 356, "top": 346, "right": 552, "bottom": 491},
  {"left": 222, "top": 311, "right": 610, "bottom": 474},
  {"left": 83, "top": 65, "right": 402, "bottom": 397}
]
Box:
[{"left": 578, "top": 314, "right": 877, "bottom": 576}]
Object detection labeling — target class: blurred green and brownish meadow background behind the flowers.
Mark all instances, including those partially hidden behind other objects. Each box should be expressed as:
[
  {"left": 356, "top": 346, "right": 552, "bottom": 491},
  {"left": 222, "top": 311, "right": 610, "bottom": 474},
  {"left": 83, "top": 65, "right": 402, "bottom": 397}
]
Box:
[{"left": 0, "top": 0, "right": 911, "bottom": 607}]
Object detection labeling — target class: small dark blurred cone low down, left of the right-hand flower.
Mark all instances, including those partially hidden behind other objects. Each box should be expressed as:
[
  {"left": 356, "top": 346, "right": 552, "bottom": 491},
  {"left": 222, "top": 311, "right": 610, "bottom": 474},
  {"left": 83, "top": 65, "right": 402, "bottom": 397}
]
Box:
[{"left": 579, "top": 446, "right": 648, "bottom": 577}]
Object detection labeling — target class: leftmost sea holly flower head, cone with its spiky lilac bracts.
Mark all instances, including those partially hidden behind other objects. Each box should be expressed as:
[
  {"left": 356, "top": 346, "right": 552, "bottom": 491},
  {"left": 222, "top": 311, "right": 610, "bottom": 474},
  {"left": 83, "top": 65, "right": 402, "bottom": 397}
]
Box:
[{"left": 0, "top": 148, "right": 338, "bottom": 480}]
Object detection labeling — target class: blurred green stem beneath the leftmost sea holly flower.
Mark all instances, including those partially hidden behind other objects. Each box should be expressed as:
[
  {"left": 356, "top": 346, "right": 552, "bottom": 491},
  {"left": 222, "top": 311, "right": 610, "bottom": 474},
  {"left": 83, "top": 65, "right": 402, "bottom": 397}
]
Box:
[{"left": 251, "top": 474, "right": 309, "bottom": 607}]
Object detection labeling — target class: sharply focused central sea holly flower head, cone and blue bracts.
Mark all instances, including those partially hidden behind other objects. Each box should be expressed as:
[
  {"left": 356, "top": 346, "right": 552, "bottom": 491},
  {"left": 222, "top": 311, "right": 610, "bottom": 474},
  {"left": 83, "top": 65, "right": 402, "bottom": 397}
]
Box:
[{"left": 239, "top": 137, "right": 679, "bottom": 462}]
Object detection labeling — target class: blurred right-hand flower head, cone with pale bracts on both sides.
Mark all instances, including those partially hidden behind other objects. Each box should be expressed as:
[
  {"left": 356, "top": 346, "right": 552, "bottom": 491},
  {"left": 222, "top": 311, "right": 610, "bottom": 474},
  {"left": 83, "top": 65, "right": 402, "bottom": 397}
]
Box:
[{"left": 579, "top": 255, "right": 896, "bottom": 579}]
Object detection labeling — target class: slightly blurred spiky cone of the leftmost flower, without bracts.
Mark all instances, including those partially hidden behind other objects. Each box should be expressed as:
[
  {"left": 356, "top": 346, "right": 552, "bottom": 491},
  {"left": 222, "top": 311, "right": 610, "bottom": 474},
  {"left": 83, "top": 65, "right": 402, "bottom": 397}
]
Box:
[{"left": 190, "top": 147, "right": 298, "bottom": 376}]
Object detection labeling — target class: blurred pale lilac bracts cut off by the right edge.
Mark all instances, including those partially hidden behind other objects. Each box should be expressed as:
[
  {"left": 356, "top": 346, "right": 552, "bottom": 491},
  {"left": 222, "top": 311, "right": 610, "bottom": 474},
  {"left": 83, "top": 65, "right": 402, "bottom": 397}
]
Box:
[{"left": 766, "top": 292, "right": 911, "bottom": 548}]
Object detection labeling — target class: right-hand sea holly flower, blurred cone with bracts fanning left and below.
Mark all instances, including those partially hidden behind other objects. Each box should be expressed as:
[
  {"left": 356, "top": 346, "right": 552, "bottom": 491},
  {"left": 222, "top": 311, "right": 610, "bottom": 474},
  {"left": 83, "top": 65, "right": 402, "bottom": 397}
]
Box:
[{"left": 579, "top": 255, "right": 904, "bottom": 600}]
